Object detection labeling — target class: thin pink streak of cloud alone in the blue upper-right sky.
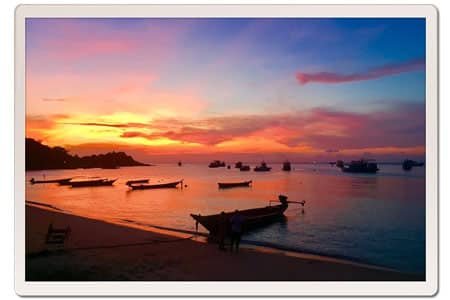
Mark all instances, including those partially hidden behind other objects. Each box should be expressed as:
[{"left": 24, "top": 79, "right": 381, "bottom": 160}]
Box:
[{"left": 296, "top": 59, "right": 425, "bottom": 85}]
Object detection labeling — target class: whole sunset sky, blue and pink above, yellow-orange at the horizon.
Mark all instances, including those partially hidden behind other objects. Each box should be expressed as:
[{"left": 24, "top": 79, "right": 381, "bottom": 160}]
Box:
[{"left": 26, "top": 18, "right": 425, "bottom": 162}]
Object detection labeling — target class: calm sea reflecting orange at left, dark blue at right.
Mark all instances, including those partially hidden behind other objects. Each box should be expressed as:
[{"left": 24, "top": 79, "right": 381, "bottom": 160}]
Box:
[{"left": 26, "top": 164, "right": 425, "bottom": 274}]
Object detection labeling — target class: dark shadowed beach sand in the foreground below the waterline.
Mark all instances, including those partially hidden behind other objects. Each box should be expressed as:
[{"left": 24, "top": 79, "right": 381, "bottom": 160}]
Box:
[{"left": 26, "top": 205, "right": 421, "bottom": 281}]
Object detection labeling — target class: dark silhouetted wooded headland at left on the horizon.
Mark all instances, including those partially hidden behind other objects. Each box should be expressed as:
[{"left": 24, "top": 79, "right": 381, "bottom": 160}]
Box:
[{"left": 25, "top": 138, "right": 149, "bottom": 171}]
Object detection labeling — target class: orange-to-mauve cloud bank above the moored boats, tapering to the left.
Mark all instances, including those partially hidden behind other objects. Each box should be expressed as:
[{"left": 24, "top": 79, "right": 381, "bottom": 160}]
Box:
[{"left": 121, "top": 103, "right": 425, "bottom": 153}]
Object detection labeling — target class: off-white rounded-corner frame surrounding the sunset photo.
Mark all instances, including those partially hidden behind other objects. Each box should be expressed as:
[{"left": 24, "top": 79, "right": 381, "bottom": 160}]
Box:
[{"left": 15, "top": 4, "right": 438, "bottom": 296}]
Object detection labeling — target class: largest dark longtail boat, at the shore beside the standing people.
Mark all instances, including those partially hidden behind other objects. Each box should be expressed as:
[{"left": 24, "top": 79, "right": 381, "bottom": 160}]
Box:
[{"left": 191, "top": 195, "right": 300, "bottom": 236}]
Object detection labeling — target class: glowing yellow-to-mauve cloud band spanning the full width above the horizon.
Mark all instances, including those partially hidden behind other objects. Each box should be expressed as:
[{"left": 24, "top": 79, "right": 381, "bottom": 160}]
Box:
[{"left": 27, "top": 102, "right": 425, "bottom": 155}]
